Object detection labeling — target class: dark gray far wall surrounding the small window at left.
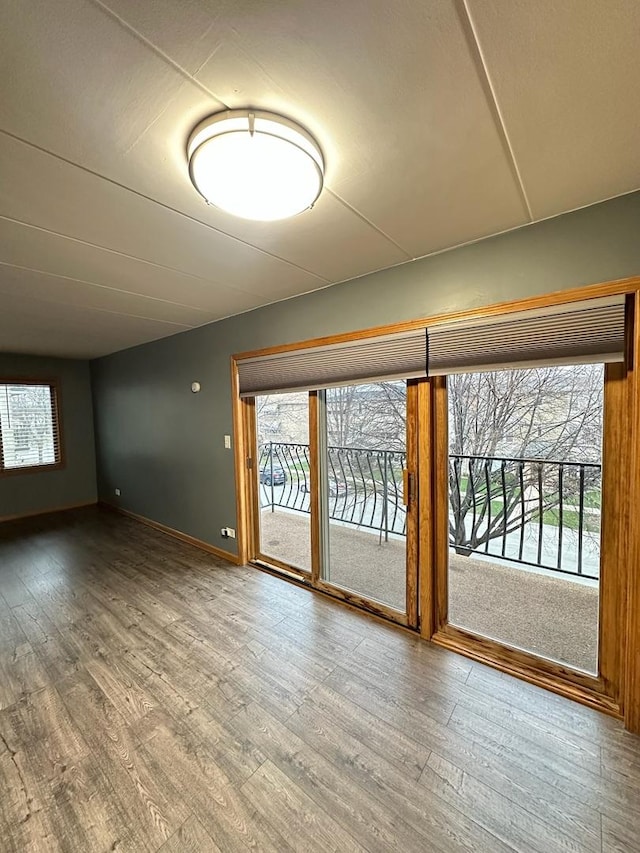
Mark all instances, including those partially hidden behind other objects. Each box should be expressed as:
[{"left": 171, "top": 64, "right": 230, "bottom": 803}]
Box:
[{"left": 0, "top": 353, "right": 97, "bottom": 519}]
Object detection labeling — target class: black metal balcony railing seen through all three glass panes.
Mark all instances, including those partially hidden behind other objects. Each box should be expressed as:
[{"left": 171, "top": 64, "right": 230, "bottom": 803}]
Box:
[{"left": 258, "top": 442, "right": 601, "bottom": 579}]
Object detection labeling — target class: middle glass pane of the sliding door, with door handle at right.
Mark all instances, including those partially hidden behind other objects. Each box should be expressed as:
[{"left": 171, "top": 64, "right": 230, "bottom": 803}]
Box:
[{"left": 319, "top": 381, "right": 408, "bottom": 613}]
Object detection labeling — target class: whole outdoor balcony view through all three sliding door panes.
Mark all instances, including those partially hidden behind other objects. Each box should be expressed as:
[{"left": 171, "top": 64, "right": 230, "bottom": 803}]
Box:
[{"left": 256, "top": 364, "right": 604, "bottom": 673}]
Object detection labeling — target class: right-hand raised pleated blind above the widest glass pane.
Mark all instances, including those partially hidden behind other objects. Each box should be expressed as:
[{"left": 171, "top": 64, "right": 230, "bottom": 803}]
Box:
[{"left": 428, "top": 296, "right": 625, "bottom": 376}]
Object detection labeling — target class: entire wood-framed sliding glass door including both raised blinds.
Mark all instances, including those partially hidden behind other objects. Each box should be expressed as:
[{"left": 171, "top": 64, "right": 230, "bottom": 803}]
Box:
[{"left": 234, "top": 286, "right": 638, "bottom": 713}]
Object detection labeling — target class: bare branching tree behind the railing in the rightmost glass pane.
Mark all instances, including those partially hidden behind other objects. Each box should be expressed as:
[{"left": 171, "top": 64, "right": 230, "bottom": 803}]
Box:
[{"left": 448, "top": 365, "right": 603, "bottom": 554}]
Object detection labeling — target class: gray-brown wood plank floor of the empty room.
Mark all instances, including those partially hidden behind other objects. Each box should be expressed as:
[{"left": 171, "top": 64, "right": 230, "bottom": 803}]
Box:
[{"left": 0, "top": 509, "right": 640, "bottom": 853}]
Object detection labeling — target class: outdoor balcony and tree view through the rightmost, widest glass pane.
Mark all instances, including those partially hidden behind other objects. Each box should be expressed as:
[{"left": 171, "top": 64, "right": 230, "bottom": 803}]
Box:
[{"left": 447, "top": 365, "right": 604, "bottom": 673}]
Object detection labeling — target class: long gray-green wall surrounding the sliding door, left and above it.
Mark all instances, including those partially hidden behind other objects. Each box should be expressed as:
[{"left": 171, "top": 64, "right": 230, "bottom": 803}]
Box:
[{"left": 92, "top": 193, "right": 640, "bottom": 550}]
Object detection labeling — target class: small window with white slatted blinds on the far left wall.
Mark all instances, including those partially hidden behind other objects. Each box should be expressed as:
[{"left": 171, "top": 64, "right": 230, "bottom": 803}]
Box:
[{"left": 0, "top": 380, "right": 62, "bottom": 474}]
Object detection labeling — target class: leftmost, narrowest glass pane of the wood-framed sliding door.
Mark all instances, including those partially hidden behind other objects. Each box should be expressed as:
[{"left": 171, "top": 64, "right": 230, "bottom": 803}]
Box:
[{"left": 255, "top": 391, "right": 311, "bottom": 572}]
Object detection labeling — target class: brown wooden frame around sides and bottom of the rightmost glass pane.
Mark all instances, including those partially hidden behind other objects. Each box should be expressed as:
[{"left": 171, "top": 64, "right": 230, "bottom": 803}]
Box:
[{"left": 421, "top": 293, "right": 640, "bottom": 730}]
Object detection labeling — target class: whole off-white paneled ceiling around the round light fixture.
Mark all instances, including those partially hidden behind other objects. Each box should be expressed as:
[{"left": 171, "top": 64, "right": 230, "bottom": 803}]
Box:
[{"left": 0, "top": 0, "right": 640, "bottom": 358}]
